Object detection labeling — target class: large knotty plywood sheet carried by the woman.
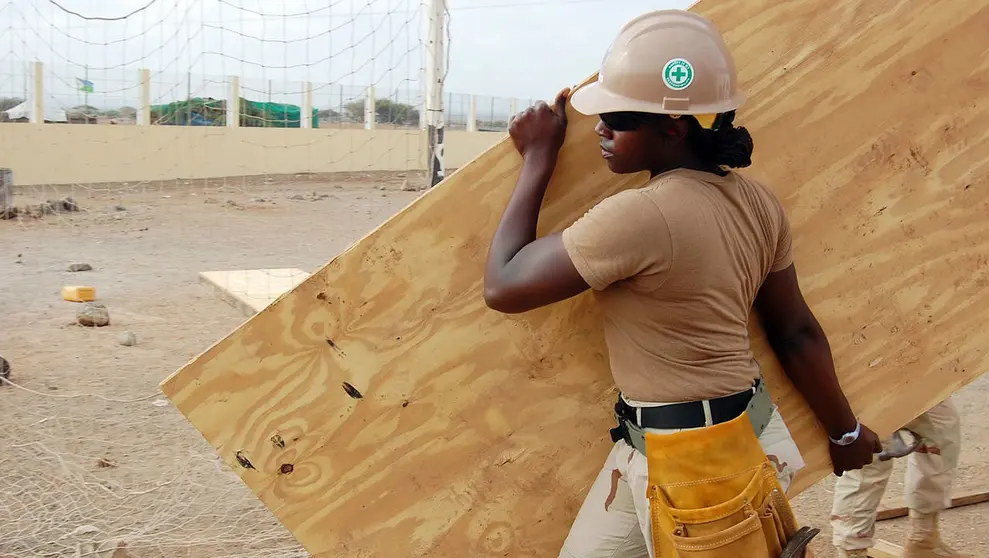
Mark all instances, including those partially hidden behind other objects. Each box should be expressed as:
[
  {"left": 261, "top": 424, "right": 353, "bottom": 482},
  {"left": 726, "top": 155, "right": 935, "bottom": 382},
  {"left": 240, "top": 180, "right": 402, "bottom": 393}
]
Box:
[{"left": 162, "top": 0, "right": 989, "bottom": 557}]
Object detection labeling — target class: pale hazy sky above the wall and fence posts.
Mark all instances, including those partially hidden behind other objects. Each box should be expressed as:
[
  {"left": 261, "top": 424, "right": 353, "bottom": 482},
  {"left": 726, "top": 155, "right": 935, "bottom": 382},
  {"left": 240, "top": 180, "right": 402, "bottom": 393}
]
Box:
[{"left": 0, "top": 0, "right": 691, "bottom": 115}]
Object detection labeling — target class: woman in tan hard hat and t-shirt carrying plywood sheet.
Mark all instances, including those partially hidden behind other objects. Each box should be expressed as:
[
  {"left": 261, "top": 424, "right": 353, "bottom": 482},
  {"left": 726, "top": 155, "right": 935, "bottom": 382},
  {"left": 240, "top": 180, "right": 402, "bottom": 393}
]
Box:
[{"left": 484, "top": 10, "right": 881, "bottom": 558}]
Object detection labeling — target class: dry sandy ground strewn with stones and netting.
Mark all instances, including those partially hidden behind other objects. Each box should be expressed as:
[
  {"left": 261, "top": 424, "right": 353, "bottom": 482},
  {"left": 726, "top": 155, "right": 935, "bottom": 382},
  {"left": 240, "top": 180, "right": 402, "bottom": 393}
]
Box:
[{"left": 0, "top": 174, "right": 989, "bottom": 558}]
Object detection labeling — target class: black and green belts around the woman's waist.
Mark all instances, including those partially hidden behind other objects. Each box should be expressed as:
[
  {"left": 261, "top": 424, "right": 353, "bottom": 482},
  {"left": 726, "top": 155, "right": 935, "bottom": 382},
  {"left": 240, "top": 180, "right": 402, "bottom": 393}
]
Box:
[{"left": 611, "top": 378, "right": 775, "bottom": 460}]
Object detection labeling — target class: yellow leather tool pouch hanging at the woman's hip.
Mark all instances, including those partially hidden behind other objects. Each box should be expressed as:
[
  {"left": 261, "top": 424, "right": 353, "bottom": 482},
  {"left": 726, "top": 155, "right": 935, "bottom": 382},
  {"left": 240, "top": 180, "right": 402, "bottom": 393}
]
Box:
[{"left": 646, "top": 414, "right": 816, "bottom": 558}]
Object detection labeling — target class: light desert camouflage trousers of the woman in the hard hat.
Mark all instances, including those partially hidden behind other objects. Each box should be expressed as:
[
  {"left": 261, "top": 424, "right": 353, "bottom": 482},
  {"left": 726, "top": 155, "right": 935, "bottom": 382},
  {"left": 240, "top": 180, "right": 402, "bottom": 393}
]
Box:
[{"left": 559, "top": 410, "right": 804, "bottom": 558}]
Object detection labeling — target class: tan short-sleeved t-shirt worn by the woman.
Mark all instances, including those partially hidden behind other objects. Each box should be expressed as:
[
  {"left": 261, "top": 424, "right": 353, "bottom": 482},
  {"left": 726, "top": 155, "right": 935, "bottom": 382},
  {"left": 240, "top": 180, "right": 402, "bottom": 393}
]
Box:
[{"left": 563, "top": 169, "right": 793, "bottom": 402}]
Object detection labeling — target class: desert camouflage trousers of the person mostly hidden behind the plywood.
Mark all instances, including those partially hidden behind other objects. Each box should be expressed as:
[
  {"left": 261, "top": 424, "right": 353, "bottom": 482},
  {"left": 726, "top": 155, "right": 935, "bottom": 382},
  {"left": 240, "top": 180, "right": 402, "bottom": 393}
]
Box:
[{"left": 831, "top": 401, "right": 961, "bottom": 550}]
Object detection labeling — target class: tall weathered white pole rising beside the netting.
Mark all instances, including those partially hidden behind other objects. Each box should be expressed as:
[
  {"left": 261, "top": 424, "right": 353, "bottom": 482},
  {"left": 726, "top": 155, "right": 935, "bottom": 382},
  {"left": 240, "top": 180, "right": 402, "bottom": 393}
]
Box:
[{"left": 425, "top": 0, "right": 446, "bottom": 188}]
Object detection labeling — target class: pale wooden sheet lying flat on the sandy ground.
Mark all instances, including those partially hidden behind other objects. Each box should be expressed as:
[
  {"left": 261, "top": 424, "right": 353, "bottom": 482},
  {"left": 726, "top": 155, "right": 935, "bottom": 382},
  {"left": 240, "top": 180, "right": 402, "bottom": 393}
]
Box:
[{"left": 199, "top": 268, "right": 309, "bottom": 316}]
